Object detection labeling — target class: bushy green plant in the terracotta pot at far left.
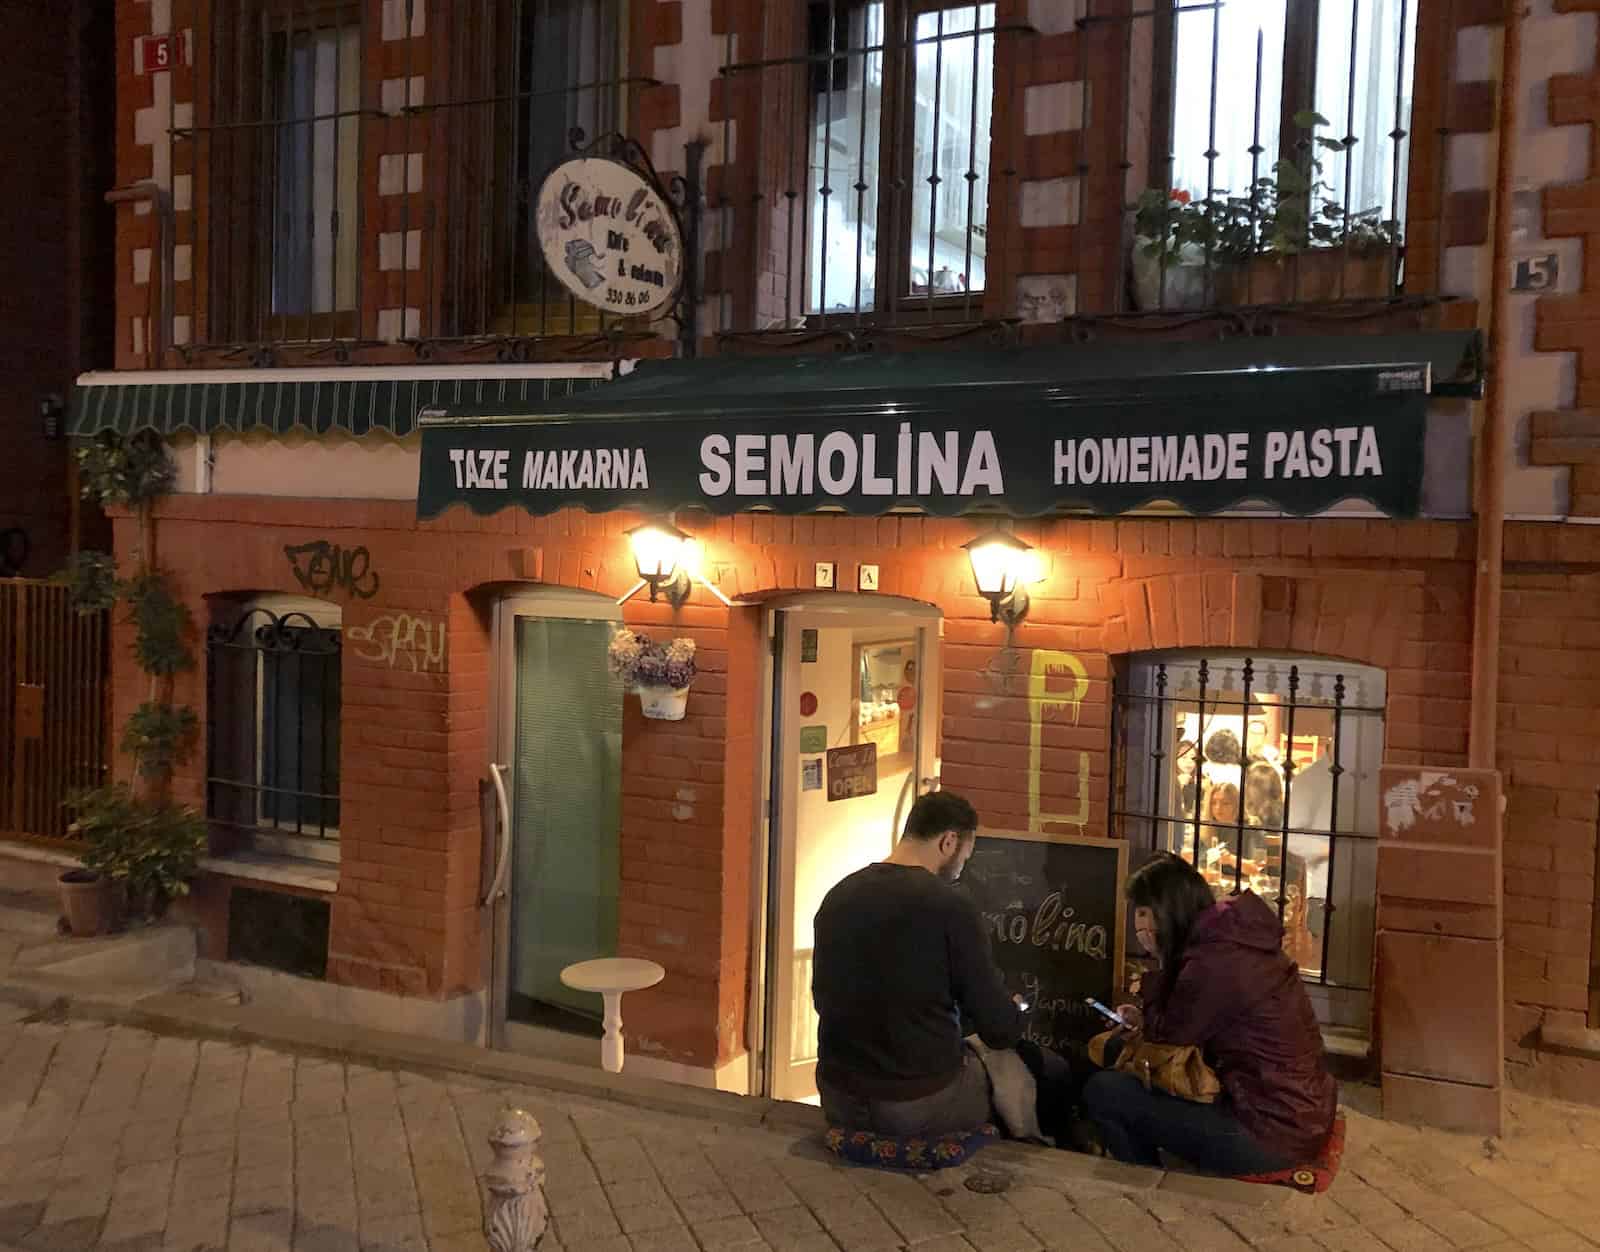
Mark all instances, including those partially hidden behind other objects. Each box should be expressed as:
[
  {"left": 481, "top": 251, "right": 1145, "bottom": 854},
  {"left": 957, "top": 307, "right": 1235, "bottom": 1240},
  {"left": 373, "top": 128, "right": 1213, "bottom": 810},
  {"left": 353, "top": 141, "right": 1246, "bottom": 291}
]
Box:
[{"left": 62, "top": 783, "right": 206, "bottom": 933}]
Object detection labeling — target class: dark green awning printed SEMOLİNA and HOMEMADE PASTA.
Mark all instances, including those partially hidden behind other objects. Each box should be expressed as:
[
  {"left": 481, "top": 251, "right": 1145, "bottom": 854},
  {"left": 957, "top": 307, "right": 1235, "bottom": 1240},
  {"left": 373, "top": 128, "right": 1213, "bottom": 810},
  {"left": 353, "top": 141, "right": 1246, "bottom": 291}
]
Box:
[{"left": 418, "top": 331, "right": 1482, "bottom": 517}]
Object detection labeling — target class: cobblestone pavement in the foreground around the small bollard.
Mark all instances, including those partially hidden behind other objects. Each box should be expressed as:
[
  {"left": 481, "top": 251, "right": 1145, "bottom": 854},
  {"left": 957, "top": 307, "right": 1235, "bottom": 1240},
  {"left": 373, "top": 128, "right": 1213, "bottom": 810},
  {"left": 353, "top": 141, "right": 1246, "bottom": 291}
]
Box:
[{"left": 0, "top": 1009, "right": 1600, "bottom": 1252}]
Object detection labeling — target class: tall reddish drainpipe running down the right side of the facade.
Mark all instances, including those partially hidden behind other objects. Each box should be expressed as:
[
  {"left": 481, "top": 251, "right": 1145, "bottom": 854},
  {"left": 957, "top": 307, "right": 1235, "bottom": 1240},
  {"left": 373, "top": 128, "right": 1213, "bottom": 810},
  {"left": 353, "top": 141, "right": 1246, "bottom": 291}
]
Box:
[{"left": 1467, "top": 0, "right": 1526, "bottom": 770}]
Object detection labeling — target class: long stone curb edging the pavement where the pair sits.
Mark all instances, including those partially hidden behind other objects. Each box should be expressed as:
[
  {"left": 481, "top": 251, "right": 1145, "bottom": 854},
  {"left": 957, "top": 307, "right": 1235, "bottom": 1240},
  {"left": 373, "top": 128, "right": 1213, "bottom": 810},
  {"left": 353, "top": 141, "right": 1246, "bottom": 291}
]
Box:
[{"left": 0, "top": 977, "right": 1294, "bottom": 1212}]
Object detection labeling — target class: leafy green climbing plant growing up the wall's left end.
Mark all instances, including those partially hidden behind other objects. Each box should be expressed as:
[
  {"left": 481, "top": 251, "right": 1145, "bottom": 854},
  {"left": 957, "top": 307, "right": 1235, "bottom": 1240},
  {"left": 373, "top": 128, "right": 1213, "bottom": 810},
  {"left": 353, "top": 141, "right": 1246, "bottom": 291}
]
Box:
[{"left": 56, "top": 431, "right": 206, "bottom": 916}]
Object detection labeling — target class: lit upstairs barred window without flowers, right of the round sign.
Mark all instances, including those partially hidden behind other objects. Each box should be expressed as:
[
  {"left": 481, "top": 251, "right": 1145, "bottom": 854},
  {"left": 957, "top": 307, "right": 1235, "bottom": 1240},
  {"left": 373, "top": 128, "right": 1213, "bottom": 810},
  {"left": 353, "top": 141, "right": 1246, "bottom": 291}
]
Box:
[{"left": 742, "top": 0, "right": 995, "bottom": 322}]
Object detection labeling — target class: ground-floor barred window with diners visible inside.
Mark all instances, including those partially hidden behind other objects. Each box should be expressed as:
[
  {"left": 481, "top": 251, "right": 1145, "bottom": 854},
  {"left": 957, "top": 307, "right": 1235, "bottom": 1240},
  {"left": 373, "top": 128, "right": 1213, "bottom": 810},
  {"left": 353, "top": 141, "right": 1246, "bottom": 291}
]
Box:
[{"left": 1112, "top": 653, "right": 1386, "bottom": 1029}]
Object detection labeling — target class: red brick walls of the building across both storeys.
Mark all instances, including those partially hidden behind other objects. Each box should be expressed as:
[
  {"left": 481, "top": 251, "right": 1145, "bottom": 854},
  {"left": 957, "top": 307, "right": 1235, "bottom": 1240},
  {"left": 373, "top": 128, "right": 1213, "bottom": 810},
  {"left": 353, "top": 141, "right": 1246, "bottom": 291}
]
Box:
[{"left": 93, "top": 0, "right": 1600, "bottom": 1097}]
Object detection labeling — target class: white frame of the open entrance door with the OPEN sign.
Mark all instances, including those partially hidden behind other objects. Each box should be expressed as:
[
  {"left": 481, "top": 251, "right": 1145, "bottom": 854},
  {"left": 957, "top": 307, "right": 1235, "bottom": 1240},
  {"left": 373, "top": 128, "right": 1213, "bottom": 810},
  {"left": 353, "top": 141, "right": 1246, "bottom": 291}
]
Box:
[{"left": 749, "top": 592, "right": 944, "bottom": 1095}]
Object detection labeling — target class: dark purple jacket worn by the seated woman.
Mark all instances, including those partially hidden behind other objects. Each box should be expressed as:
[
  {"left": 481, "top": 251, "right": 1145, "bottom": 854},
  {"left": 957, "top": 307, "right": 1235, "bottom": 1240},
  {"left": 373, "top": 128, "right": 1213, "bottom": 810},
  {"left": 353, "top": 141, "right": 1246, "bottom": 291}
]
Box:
[{"left": 1144, "top": 892, "right": 1339, "bottom": 1162}]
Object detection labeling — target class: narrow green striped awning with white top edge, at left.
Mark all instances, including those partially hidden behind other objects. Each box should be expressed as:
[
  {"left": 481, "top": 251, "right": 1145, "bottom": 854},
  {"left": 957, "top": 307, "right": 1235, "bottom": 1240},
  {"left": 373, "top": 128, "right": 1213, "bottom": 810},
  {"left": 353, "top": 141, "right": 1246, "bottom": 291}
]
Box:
[{"left": 69, "top": 362, "right": 614, "bottom": 435}]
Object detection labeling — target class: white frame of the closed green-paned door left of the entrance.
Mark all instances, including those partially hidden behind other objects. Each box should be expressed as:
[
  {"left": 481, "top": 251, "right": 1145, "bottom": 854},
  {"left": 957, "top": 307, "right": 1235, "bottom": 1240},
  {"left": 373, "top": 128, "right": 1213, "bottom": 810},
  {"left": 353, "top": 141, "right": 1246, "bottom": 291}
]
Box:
[{"left": 483, "top": 586, "right": 622, "bottom": 1047}]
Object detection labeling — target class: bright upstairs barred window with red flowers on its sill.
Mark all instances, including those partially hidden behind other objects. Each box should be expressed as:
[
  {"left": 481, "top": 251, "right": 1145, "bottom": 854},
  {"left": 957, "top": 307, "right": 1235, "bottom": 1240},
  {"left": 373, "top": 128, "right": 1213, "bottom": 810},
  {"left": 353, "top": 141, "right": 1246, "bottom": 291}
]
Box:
[{"left": 1141, "top": 0, "right": 1418, "bottom": 304}]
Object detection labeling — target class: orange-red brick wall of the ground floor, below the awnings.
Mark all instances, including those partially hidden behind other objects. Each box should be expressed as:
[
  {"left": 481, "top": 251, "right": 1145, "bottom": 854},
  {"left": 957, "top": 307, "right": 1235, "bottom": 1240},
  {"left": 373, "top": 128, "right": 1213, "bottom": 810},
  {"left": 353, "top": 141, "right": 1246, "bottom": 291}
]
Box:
[{"left": 117, "top": 498, "right": 1600, "bottom": 1088}]
